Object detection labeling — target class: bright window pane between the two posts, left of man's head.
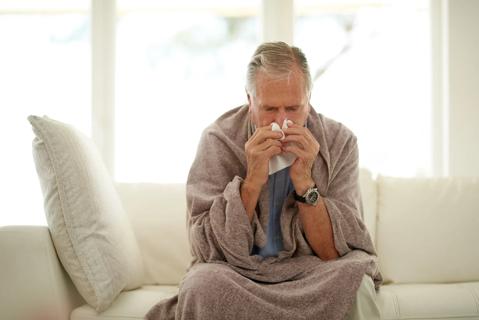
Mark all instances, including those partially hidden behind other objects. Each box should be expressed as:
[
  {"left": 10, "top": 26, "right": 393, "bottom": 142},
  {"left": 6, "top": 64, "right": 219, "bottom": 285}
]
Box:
[{"left": 115, "top": 0, "right": 259, "bottom": 182}]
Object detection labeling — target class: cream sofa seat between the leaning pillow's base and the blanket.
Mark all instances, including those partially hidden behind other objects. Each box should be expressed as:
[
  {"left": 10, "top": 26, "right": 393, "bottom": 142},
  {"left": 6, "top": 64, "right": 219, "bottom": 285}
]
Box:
[{"left": 70, "top": 285, "right": 178, "bottom": 320}]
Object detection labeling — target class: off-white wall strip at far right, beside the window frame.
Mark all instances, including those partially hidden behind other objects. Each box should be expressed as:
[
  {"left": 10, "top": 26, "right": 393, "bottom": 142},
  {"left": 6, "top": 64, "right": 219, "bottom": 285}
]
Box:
[{"left": 446, "top": 0, "right": 479, "bottom": 176}]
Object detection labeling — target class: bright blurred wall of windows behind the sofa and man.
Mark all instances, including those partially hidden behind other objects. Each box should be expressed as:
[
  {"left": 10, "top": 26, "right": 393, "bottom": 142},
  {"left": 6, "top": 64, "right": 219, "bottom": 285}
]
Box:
[{"left": 0, "top": 0, "right": 479, "bottom": 226}]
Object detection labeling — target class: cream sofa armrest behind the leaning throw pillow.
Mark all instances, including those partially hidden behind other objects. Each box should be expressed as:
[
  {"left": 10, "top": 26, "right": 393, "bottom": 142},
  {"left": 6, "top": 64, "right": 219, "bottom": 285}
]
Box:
[{"left": 0, "top": 226, "right": 85, "bottom": 320}]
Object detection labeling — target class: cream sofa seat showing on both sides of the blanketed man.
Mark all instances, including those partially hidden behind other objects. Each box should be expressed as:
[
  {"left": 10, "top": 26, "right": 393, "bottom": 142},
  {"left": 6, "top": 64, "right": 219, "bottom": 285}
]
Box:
[{"left": 70, "top": 282, "right": 479, "bottom": 320}]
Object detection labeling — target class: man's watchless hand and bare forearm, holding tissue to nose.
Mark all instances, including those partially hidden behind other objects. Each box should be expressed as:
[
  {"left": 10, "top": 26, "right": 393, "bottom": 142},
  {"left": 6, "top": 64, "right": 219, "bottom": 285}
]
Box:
[{"left": 241, "top": 126, "right": 283, "bottom": 221}]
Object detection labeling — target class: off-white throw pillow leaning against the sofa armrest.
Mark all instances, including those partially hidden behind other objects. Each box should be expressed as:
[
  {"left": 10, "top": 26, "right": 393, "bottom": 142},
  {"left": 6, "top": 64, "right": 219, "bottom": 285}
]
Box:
[{"left": 28, "top": 116, "right": 144, "bottom": 311}]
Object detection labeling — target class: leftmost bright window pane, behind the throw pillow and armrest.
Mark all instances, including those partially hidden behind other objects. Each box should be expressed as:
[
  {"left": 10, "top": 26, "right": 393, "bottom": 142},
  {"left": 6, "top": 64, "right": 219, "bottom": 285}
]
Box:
[{"left": 0, "top": 1, "right": 91, "bottom": 225}]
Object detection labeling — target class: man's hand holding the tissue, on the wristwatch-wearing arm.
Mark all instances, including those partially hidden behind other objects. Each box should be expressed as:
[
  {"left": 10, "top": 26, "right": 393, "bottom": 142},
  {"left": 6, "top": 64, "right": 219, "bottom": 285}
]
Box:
[{"left": 282, "top": 123, "right": 319, "bottom": 195}]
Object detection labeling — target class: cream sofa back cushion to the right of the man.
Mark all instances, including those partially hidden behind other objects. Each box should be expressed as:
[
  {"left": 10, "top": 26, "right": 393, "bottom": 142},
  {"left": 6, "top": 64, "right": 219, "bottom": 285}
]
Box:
[{"left": 377, "top": 177, "right": 479, "bottom": 283}]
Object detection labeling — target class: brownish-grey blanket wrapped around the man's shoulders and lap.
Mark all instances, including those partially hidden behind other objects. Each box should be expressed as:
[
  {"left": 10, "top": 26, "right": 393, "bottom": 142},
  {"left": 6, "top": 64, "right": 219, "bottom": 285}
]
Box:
[{"left": 146, "top": 106, "right": 381, "bottom": 320}]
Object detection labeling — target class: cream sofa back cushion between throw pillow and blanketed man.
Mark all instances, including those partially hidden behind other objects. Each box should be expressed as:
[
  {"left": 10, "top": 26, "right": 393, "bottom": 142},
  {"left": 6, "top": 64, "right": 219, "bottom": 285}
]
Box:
[{"left": 117, "top": 183, "right": 191, "bottom": 284}]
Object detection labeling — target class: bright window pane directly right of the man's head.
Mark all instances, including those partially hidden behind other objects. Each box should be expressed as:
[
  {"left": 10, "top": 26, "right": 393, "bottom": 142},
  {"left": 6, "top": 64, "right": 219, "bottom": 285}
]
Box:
[{"left": 295, "top": 0, "right": 432, "bottom": 176}]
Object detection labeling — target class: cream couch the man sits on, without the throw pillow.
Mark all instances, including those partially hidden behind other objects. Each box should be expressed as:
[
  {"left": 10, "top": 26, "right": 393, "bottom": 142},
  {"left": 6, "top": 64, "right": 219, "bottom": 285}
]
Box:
[{"left": 0, "top": 171, "right": 479, "bottom": 320}]
